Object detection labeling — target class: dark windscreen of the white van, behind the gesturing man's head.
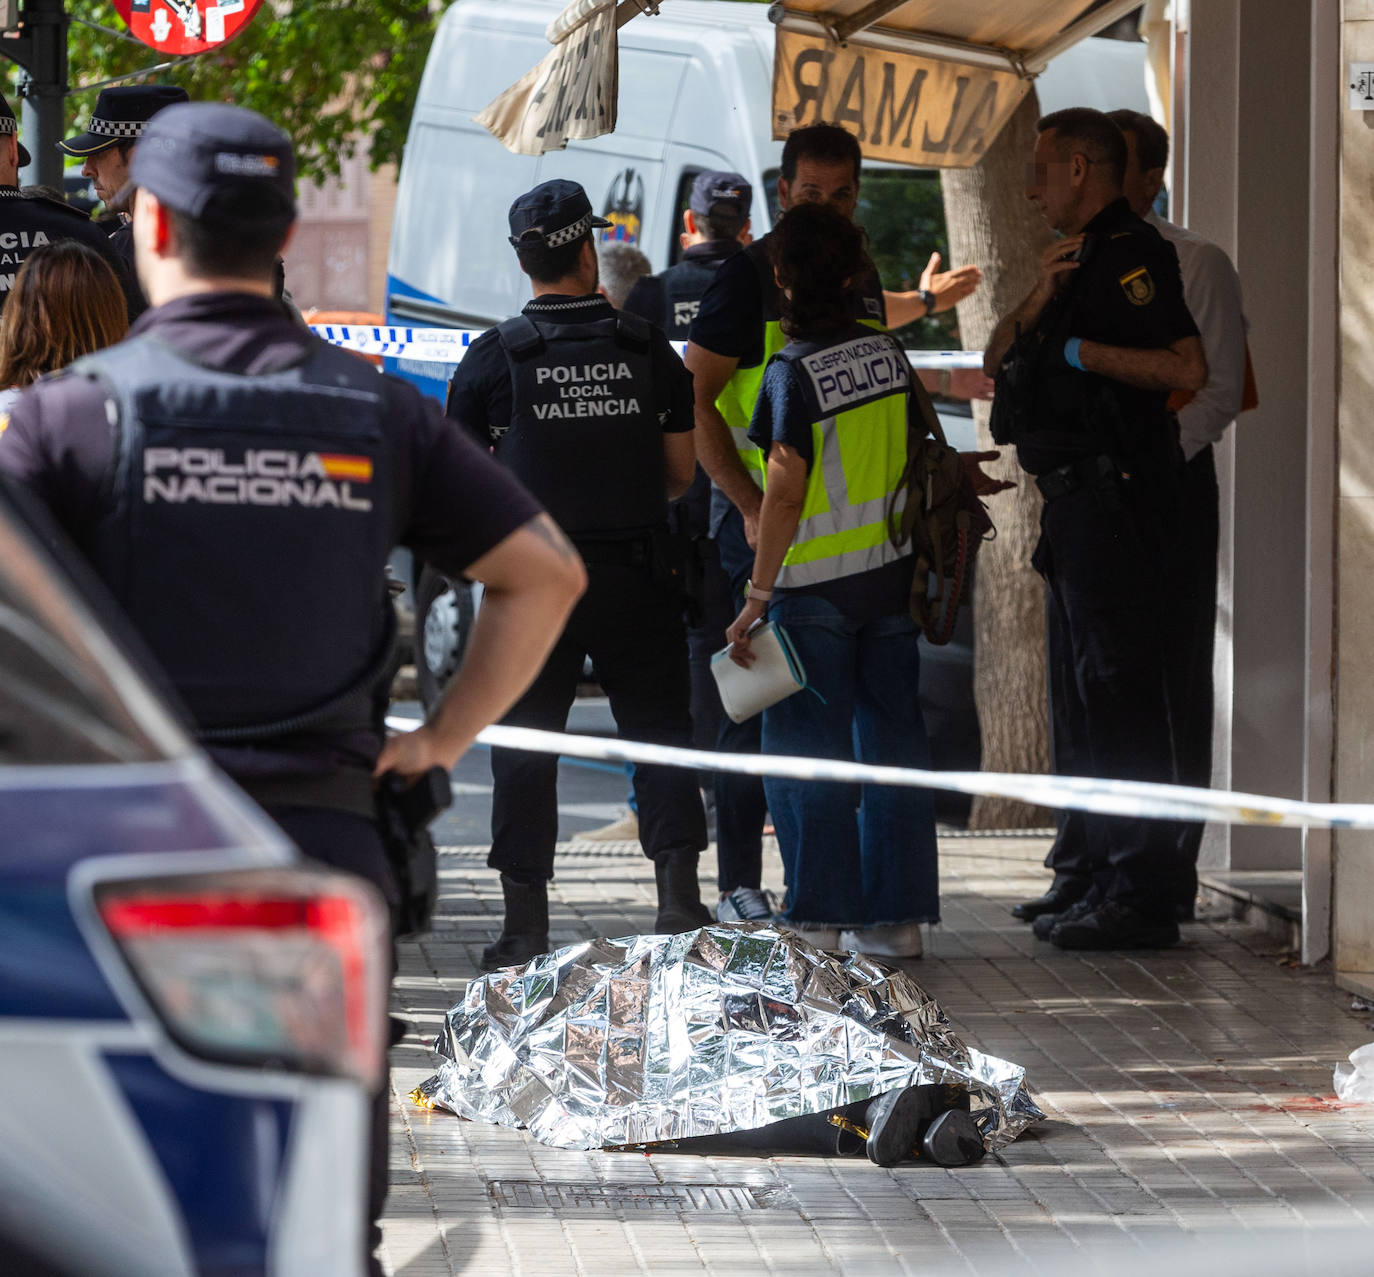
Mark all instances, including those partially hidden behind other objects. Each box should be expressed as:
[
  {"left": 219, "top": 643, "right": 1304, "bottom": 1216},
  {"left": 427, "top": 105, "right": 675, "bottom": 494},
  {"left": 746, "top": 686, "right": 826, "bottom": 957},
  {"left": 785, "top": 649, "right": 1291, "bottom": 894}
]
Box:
[{"left": 764, "top": 165, "right": 966, "bottom": 351}]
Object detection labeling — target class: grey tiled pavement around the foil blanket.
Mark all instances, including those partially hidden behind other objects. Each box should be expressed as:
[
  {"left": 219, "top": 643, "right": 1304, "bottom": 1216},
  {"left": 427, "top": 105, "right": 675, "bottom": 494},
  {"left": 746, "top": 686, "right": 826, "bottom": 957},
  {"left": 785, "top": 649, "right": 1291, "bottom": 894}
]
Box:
[{"left": 383, "top": 837, "right": 1374, "bottom": 1277}]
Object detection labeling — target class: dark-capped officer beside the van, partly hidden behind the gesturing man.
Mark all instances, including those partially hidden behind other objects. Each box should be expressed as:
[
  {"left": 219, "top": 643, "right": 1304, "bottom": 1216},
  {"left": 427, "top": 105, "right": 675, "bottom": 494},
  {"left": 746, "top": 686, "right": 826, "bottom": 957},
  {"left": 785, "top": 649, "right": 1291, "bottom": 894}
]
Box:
[{"left": 625, "top": 169, "right": 753, "bottom": 341}]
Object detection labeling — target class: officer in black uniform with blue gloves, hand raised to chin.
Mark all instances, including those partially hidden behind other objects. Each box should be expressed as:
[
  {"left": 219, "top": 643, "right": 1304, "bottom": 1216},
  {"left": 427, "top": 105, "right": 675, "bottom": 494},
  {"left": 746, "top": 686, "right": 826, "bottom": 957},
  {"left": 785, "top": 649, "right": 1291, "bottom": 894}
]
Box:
[{"left": 984, "top": 109, "right": 1208, "bottom": 948}]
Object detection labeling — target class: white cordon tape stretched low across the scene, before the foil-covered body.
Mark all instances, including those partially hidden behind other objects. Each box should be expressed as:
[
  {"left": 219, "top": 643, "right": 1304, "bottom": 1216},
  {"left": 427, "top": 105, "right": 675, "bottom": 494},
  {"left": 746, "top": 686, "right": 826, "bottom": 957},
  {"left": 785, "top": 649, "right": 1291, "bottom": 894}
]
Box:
[{"left": 386, "top": 715, "right": 1374, "bottom": 829}]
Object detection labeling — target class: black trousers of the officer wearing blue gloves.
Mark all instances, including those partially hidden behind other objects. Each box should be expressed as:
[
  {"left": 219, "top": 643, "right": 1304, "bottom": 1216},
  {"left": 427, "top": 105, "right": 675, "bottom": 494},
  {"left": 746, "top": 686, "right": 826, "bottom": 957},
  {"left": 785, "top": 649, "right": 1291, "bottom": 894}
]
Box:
[{"left": 1032, "top": 476, "right": 1187, "bottom": 918}]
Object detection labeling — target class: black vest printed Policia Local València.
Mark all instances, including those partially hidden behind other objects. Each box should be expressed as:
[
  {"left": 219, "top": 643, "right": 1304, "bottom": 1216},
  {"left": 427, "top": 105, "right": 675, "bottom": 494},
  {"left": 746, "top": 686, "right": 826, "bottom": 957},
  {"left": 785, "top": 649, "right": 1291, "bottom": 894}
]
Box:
[{"left": 496, "top": 312, "right": 668, "bottom": 537}]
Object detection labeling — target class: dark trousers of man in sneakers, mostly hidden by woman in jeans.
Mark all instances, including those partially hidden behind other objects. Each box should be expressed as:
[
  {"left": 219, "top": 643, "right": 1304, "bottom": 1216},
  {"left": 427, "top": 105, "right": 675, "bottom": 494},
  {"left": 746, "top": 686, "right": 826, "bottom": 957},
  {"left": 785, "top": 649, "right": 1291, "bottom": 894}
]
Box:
[{"left": 716, "top": 510, "right": 768, "bottom": 892}]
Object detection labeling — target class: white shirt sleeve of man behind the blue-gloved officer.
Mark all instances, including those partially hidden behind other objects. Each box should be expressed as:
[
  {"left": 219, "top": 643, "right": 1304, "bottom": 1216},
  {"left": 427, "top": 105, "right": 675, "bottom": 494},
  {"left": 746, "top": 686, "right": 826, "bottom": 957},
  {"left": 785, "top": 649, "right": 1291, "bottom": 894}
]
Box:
[{"left": 1179, "top": 242, "right": 1245, "bottom": 460}]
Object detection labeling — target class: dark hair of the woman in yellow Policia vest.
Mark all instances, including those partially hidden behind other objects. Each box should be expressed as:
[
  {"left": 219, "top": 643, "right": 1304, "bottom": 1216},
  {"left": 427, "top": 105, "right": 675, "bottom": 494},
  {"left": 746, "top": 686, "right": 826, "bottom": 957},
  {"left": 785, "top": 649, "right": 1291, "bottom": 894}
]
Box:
[{"left": 768, "top": 203, "right": 868, "bottom": 338}]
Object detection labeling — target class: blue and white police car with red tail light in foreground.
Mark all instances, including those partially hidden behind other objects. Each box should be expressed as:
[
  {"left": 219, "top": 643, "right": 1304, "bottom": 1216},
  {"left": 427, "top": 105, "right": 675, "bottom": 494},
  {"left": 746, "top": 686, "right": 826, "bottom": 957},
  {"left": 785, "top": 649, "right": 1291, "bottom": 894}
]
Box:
[{"left": 0, "top": 483, "right": 389, "bottom": 1277}]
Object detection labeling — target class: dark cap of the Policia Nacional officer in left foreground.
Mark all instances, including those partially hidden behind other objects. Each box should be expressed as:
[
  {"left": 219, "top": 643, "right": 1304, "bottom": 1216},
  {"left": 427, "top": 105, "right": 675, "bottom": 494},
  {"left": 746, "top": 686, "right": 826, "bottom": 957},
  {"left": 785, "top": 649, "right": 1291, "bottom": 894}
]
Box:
[{"left": 118, "top": 102, "right": 295, "bottom": 219}]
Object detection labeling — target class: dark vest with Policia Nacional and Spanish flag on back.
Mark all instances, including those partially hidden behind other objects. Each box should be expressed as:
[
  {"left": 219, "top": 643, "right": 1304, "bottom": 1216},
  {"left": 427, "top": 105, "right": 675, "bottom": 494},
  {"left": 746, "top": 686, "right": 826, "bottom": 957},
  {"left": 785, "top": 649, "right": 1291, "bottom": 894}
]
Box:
[{"left": 71, "top": 337, "right": 394, "bottom": 740}]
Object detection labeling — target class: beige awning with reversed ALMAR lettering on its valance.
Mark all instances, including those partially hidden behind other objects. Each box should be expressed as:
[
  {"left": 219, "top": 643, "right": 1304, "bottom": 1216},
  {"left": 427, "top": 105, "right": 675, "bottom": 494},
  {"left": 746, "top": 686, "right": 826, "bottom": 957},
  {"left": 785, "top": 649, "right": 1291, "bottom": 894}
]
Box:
[{"left": 772, "top": 0, "right": 1140, "bottom": 168}]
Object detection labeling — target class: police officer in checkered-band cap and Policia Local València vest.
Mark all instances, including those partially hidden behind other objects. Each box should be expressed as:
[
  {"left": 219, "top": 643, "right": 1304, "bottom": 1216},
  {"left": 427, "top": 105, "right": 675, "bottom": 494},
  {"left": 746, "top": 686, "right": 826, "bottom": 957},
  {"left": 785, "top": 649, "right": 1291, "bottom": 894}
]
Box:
[{"left": 448, "top": 180, "right": 710, "bottom": 969}]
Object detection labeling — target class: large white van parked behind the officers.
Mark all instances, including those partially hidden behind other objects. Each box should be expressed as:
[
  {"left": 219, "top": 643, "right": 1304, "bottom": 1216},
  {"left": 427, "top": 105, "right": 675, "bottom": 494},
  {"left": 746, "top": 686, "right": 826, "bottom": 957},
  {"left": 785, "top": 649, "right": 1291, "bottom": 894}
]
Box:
[{"left": 386, "top": 0, "right": 1149, "bottom": 401}]
